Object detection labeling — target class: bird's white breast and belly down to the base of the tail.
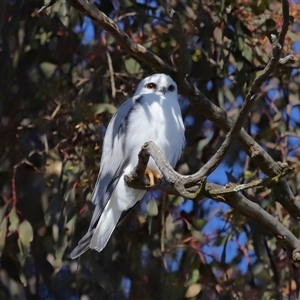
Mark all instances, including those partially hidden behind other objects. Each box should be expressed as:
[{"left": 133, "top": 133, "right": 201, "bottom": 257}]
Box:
[{"left": 112, "top": 94, "right": 184, "bottom": 211}]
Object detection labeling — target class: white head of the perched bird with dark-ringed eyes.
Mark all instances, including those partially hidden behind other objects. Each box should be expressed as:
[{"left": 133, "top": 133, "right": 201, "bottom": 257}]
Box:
[{"left": 135, "top": 74, "right": 177, "bottom": 99}]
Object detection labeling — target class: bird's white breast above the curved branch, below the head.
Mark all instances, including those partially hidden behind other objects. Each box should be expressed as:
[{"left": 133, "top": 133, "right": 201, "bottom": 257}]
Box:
[{"left": 127, "top": 93, "right": 184, "bottom": 171}]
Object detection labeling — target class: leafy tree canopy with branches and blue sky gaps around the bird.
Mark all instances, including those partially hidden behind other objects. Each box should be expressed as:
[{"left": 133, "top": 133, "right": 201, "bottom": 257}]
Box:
[{"left": 0, "top": 0, "right": 300, "bottom": 300}]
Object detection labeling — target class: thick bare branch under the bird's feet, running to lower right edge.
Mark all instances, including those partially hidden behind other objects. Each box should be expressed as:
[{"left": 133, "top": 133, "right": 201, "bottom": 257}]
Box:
[{"left": 125, "top": 142, "right": 300, "bottom": 260}]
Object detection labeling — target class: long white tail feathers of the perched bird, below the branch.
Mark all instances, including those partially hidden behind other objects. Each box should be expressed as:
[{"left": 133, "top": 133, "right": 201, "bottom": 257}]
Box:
[{"left": 90, "top": 198, "right": 122, "bottom": 252}]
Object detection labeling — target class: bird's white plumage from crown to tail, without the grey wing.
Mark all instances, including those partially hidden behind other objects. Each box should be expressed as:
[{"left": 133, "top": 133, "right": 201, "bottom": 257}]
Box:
[{"left": 90, "top": 74, "right": 184, "bottom": 251}]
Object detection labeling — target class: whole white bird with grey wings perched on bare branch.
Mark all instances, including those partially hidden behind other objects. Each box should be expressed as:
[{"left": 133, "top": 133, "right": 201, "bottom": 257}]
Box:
[{"left": 71, "top": 74, "right": 185, "bottom": 259}]
